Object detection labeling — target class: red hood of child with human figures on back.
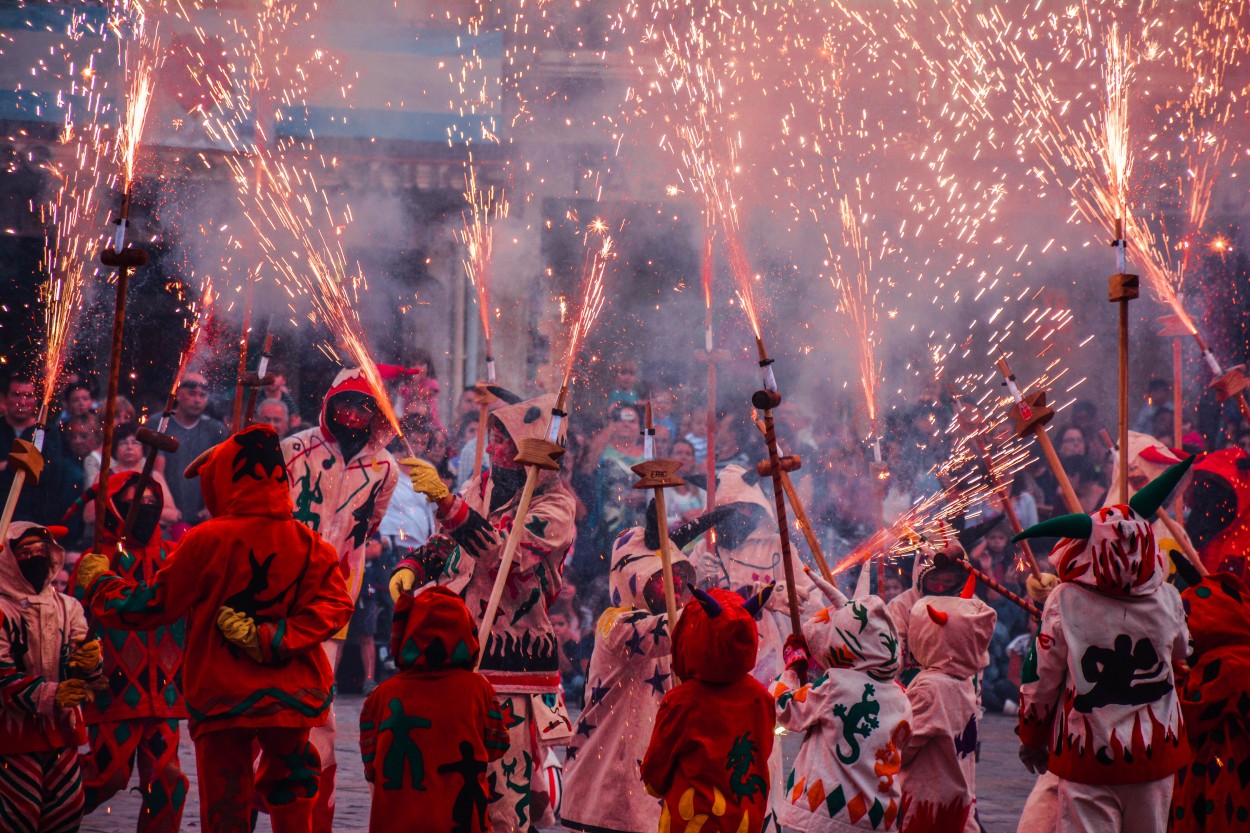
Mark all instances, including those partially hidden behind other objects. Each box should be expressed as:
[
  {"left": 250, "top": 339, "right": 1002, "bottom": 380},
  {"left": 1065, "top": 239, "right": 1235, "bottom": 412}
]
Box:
[{"left": 391, "top": 587, "right": 478, "bottom": 670}]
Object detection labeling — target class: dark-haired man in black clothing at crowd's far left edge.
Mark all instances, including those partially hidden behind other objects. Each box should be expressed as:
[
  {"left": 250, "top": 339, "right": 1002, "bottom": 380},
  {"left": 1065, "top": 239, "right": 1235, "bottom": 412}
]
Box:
[{"left": 0, "top": 375, "right": 73, "bottom": 525}]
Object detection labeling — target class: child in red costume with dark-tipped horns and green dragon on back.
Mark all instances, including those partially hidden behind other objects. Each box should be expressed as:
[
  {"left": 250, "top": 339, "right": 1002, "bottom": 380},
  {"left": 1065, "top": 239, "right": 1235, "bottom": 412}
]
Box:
[{"left": 641, "top": 587, "right": 776, "bottom": 833}]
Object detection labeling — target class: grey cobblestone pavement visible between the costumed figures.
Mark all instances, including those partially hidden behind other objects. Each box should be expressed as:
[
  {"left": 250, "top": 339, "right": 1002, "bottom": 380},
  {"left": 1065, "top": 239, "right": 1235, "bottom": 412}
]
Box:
[{"left": 83, "top": 694, "right": 1034, "bottom": 833}]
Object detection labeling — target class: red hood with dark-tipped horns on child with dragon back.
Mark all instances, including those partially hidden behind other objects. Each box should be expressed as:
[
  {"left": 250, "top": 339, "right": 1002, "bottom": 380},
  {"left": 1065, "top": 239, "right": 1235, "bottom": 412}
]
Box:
[{"left": 673, "top": 588, "right": 760, "bottom": 683}]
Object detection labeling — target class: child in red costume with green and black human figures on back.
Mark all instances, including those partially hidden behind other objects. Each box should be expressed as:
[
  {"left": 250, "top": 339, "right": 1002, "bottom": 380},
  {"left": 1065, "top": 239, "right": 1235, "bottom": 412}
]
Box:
[{"left": 360, "top": 587, "right": 508, "bottom": 833}]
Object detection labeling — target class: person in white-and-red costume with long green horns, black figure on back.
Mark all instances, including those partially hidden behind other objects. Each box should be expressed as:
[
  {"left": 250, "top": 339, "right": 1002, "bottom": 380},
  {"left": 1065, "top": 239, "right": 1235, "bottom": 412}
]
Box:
[{"left": 1016, "top": 460, "right": 1191, "bottom": 832}]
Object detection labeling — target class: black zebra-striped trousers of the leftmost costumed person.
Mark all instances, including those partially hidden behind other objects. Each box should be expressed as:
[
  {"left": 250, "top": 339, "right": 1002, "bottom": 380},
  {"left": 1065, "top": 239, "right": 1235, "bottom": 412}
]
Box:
[{"left": 0, "top": 748, "right": 83, "bottom": 833}]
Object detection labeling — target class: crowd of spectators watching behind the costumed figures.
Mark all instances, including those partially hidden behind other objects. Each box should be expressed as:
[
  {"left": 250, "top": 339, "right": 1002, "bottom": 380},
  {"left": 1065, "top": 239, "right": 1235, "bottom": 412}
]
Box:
[{"left": 0, "top": 355, "right": 1250, "bottom": 709}]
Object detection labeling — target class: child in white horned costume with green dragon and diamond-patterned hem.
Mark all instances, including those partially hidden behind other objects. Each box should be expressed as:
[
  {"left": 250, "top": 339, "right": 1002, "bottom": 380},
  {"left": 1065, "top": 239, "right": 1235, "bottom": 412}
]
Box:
[{"left": 770, "top": 574, "right": 911, "bottom": 833}]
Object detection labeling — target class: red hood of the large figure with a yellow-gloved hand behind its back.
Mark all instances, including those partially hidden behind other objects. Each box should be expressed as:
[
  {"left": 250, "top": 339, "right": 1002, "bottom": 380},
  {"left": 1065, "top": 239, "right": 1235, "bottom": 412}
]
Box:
[{"left": 200, "top": 424, "right": 294, "bottom": 518}]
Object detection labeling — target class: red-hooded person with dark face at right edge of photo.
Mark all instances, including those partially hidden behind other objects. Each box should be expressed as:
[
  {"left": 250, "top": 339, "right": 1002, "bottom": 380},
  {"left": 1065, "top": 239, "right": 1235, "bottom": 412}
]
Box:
[{"left": 1185, "top": 448, "right": 1250, "bottom": 580}]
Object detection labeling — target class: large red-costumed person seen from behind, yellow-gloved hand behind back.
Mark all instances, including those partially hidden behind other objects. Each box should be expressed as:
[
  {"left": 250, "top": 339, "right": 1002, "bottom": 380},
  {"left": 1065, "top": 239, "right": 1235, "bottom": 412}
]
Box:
[{"left": 78, "top": 424, "right": 353, "bottom": 833}]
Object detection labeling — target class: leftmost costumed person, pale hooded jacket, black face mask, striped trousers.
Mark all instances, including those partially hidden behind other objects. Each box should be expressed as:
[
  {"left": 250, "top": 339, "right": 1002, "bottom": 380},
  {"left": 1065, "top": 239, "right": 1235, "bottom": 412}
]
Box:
[{"left": 0, "top": 522, "right": 99, "bottom": 833}]
